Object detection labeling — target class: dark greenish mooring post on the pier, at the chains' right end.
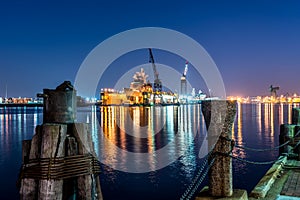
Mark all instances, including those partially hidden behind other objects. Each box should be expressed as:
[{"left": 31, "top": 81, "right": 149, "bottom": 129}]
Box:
[{"left": 279, "top": 108, "right": 300, "bottom": 160}]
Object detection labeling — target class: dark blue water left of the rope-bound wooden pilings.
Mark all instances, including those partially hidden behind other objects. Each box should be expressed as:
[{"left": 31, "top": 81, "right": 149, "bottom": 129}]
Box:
[{"left": 0, "top": 107, "right": 42, "bottom": 200}]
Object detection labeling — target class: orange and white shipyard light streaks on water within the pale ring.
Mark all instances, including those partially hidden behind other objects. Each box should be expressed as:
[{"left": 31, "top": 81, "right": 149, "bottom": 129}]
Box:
[{"left": 92, "top": 105, "right": 203, "bottom": 175}]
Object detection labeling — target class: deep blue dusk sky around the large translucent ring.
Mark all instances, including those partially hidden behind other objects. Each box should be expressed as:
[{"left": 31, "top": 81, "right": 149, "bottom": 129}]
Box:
[{"left": 0, "top": 0, "right": 300, "bottom": 97}]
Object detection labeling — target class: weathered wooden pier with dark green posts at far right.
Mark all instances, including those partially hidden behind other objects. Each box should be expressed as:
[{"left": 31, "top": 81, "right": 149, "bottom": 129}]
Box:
[{"left": 250, "top": 108, "right": 300, "bottom": 200}]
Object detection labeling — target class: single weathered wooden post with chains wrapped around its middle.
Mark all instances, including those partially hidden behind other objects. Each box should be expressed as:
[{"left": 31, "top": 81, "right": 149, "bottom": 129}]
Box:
[{"left": 202, "top": 100, "right": 236, "bottom": 197}]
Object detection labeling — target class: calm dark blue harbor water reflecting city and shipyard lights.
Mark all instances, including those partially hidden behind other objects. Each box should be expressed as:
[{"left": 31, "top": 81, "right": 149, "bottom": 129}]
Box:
[{"left": 0, "top": 104, "right": 299, "bottom": 200}]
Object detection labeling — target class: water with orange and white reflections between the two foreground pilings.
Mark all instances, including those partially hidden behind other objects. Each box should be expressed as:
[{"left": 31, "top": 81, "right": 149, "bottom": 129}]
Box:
[{"left": 78, "top": 105, "right": 206, "bottom": 199}]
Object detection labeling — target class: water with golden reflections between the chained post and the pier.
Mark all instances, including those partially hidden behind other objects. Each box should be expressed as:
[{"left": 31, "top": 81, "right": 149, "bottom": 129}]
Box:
[{"left": 232, "top": 103, "right": 299, "bottom": 191}]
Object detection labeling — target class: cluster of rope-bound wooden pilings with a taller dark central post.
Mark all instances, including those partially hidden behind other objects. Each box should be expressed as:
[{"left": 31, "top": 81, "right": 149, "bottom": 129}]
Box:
[{"left": 20, "top": 81, "right": 103, "bottom": 200}]
